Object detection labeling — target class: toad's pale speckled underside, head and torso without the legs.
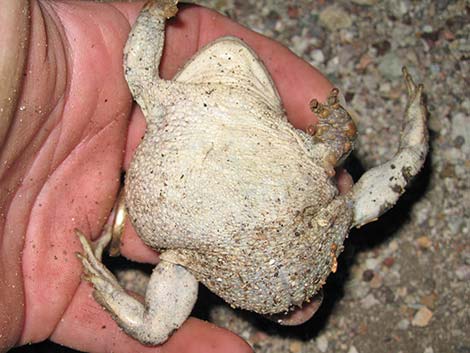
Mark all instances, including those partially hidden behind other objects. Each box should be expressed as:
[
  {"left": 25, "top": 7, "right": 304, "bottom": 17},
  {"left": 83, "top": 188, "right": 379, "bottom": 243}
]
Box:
[{"left": 126, "top": 2, "right": 352, "bottom": 314}]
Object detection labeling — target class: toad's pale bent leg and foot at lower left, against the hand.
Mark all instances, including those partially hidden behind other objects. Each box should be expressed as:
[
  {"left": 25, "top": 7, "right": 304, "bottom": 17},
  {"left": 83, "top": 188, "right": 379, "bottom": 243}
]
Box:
[{"left": 76, "top": 231, "right": 198, "bottom": 345}]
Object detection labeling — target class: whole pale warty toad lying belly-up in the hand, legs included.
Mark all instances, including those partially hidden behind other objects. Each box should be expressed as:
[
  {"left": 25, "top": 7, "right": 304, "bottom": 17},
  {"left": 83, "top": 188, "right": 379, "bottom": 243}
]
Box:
[{"left": 79, "top": 0, "right": 427, "bottom": 344}]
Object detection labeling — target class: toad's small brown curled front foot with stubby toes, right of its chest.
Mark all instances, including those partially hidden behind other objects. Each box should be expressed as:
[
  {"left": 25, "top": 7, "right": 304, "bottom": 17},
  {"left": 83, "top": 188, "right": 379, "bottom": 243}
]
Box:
[{"left": 307, "top": 88, "right": 356, "bottom": 173}]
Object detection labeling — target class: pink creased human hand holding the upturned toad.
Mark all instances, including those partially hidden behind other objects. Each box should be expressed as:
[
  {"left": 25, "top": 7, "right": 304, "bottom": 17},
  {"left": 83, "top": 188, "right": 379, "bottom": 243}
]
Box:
[{"left": 0, "top": 0, "right": 351, "bottom": 353}]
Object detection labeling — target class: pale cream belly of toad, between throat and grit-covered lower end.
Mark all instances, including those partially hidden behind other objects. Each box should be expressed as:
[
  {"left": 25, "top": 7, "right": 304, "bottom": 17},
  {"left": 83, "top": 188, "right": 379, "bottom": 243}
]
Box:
[{"left": 126, "top": 91, "right": 337, "bottom": 249}]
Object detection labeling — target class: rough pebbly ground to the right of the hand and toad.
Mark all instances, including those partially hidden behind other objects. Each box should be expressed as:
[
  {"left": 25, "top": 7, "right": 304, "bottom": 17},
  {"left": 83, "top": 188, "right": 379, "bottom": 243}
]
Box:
[{"left": 15, "top": 0, "right": 470, "bottom": 353}]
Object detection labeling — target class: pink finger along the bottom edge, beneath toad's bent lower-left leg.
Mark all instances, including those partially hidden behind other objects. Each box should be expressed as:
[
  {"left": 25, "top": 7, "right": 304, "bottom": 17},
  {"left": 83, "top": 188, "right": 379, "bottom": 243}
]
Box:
[{"left": 51, "top": 282, "right": 252, "bottom": 353}]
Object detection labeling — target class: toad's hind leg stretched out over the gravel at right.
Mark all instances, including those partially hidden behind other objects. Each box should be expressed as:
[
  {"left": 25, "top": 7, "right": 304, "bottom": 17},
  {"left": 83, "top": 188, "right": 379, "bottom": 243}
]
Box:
[{"left": 352, "top": 68, "right": 428, "bottom": 227}]
